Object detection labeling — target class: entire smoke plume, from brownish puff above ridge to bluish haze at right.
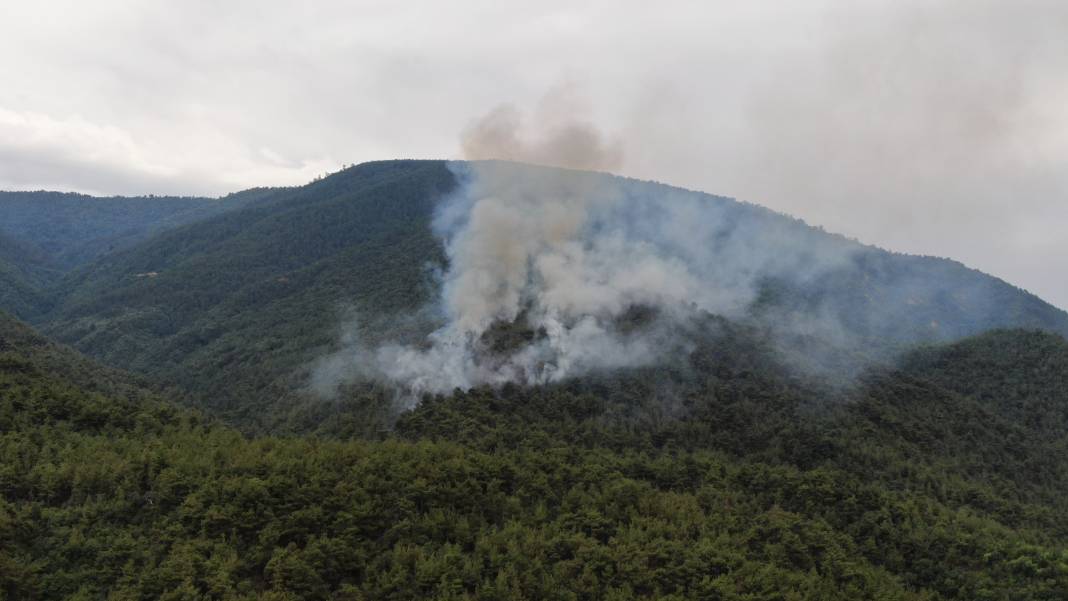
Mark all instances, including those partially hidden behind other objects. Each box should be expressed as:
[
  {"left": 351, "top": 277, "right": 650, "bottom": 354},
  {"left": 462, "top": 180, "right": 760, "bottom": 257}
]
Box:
[{"left": 312, "top": 78, "right": 1059, "bottom": 404}]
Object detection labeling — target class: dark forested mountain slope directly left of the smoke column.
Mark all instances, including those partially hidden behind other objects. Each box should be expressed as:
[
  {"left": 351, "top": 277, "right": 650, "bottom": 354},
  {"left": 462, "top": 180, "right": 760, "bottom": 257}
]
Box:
[{"left": 44, "top": 162, "right": 453, "bottom": 422}]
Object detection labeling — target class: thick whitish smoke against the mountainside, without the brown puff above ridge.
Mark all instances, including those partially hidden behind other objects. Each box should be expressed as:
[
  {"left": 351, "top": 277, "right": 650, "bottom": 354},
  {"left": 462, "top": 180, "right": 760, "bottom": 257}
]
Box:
[{"left": 319, "top": 161, "right": 855, "bottom": 403}]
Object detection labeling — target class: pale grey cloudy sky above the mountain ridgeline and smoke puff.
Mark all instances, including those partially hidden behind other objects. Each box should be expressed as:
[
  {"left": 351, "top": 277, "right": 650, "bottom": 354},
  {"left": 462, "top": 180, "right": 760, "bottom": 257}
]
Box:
[{"left": 0, "top": 0, "right": 1068, "bottom": 306}]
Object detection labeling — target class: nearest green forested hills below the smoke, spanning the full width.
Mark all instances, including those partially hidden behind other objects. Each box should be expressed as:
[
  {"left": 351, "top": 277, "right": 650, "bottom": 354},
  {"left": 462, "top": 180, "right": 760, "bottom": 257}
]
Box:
[{"left": 0, "top": 316, "right": 1068, "bottom": 600}]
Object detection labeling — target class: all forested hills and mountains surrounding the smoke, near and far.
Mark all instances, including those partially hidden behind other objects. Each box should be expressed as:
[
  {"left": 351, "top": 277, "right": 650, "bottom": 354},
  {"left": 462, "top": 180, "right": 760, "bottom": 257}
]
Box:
[{"left": 0, "top": 161, "right": 1068, "bottom": 601}]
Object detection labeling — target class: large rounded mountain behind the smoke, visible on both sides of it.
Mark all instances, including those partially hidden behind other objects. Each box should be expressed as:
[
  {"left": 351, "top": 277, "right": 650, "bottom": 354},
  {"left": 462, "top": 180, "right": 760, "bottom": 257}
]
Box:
[{"left": 4, "top": 161, "right": 1068, "bottom": 428}]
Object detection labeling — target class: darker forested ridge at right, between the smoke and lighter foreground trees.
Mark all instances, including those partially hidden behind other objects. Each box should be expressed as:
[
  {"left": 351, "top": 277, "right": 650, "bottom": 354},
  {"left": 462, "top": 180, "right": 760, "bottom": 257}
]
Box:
[{"left": 397, "top": 320, "right": 1068, "bottom": 523}]
